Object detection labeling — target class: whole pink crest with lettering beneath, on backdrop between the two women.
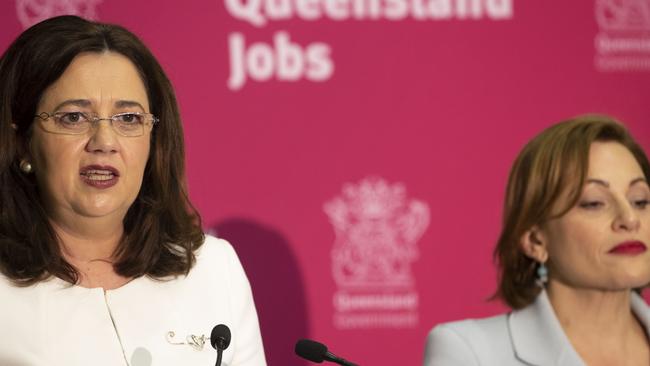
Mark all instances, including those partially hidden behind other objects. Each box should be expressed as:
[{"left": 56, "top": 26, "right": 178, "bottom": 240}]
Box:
[{"left": 324, "top": 177, "right": 429, "bottom": 329}]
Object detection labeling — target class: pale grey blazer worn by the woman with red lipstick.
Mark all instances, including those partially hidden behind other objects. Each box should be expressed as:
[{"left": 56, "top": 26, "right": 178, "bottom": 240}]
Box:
[{"left": 424, "top": 291, "right": 650, "bottom": 366}]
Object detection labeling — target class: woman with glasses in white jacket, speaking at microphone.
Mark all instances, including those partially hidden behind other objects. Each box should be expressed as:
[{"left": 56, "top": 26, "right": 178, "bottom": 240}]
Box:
[{"left": 0, "top": 16, "right": 266, "bottom": 366}]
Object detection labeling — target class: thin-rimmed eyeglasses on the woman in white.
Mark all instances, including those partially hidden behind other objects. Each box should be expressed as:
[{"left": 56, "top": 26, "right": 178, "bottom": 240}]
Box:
[{"left": 35, "top": 112, "right": 158, "bottom": 137}]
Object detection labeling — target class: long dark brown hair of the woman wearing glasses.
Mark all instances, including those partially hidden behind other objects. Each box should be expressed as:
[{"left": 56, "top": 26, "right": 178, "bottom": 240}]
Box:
[{"left": 0, "top": 16, "right": 204, "bottom": 285}]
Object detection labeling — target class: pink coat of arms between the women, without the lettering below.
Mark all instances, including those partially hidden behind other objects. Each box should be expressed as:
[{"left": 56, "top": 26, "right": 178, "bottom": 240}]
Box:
[{"left": 325, "top": 178, "right": 429, "bottom": 287}]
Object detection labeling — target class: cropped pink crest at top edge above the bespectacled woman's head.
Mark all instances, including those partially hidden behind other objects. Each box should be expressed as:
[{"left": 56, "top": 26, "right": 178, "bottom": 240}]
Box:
[{"left": 16, "top": 0, "right": 102, "bottom": 28}]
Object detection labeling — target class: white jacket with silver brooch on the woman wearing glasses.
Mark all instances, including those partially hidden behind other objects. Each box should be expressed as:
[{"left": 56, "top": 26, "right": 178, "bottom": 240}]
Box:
[{"left": 0, "top": 235, "right": 266, "bottom": 366}]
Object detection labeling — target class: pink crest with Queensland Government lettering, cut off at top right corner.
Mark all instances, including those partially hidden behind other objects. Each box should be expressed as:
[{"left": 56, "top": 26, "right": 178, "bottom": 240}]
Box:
[{"left": 594, "top": 0, "right": 650, "bottom": 72}]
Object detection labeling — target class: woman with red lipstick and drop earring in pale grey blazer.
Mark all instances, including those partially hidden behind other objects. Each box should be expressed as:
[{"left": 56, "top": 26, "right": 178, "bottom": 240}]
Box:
[{"left": 424, "top": 116, "right": 650, "bottom": 366}]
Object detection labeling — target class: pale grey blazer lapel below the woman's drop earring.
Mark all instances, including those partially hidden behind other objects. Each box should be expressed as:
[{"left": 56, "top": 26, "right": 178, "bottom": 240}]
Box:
[{"left": 508, "top": 291, "right": 584, "bottom": 366}]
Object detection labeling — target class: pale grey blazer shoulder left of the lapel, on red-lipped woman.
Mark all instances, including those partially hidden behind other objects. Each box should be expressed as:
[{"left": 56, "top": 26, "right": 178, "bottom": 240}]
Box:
[{"left": 424, "top": 314, "right": 512, "bottom": 366}]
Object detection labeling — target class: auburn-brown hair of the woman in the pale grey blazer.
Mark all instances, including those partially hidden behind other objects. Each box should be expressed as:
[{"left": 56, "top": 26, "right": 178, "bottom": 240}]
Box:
[{"left": 494, "top": 115, "right": 650, "bottom": 309}]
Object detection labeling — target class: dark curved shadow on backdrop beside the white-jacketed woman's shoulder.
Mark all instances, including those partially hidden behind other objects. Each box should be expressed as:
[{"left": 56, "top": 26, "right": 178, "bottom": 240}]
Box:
[{"left": 210, "top": 218, "right": 309, "bottom": 366}]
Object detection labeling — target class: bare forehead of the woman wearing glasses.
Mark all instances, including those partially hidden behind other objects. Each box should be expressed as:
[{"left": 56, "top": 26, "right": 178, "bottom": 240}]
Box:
[{"left": 39, "top": 52, "right": 149, "bottom": 111}]
